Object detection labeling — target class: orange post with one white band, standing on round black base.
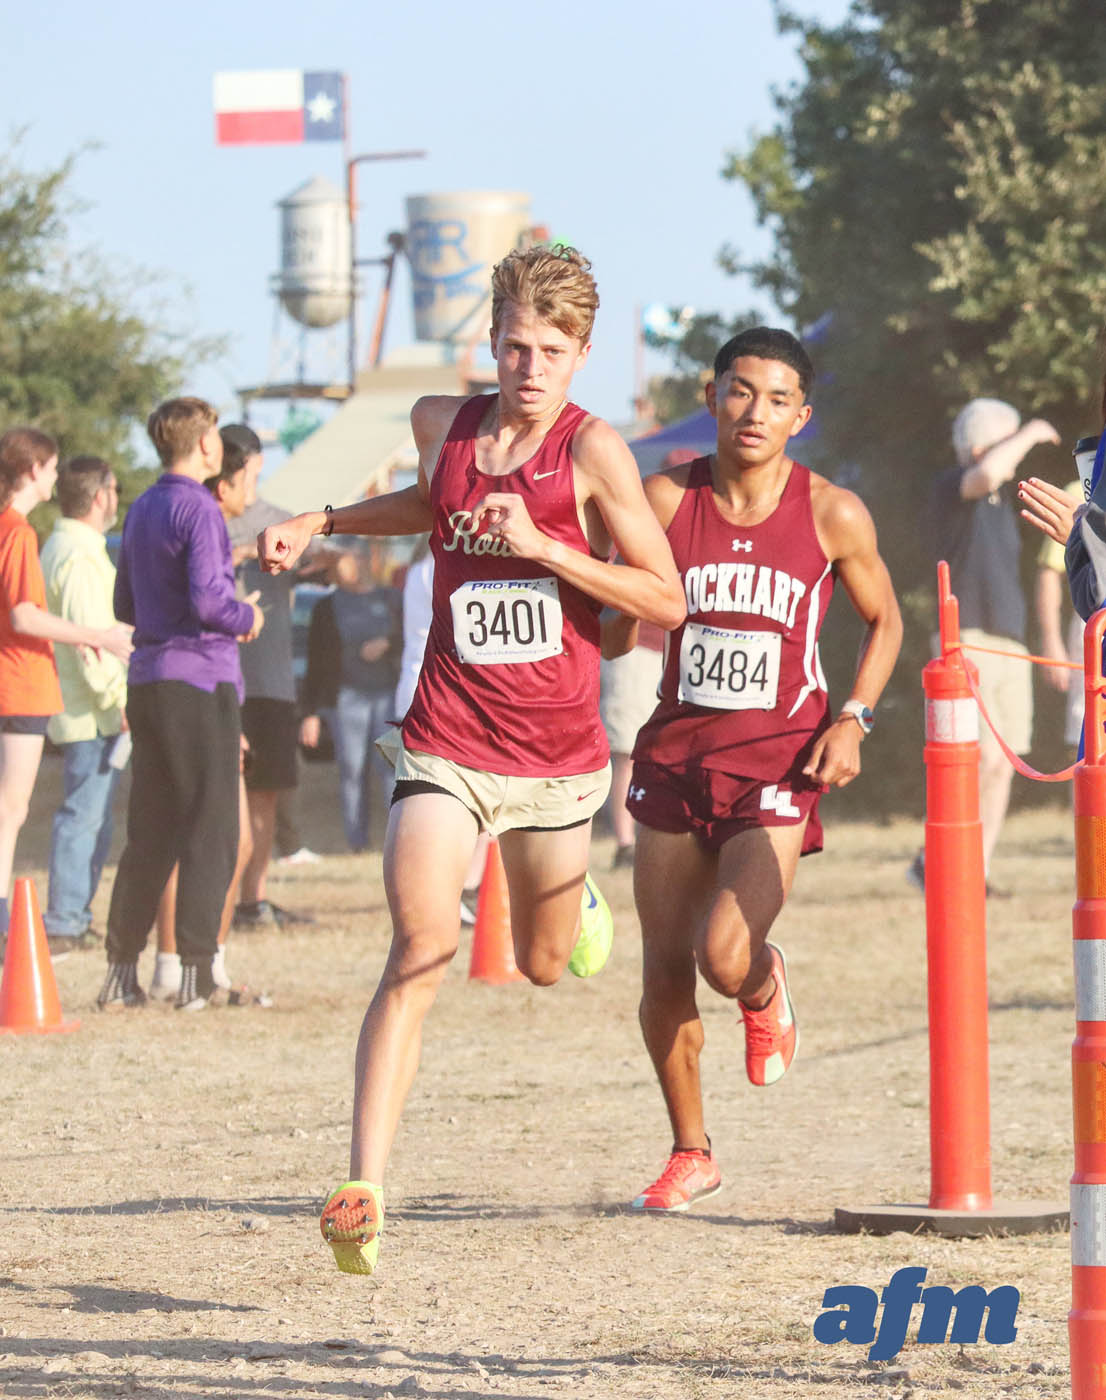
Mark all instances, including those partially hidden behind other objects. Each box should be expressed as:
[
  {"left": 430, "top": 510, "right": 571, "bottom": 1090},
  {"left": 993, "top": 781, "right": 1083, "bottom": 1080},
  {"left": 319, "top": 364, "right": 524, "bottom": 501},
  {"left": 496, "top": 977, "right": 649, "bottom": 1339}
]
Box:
[{"left": 923, "top": 561, "right": 993, "bottom": 1211}]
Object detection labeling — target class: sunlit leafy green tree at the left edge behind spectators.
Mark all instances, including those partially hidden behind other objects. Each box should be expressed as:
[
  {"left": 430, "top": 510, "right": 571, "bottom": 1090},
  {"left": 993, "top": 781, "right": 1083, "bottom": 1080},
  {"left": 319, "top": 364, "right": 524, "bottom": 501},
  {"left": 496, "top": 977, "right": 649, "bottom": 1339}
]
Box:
[{"left": 0, "top": 146, "right": 221, "bottom": 525}]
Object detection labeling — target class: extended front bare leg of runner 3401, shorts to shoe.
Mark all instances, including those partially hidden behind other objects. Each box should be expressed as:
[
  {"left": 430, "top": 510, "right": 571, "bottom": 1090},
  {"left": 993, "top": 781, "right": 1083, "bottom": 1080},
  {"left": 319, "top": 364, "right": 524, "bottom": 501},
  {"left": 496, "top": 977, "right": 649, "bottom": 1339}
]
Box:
[{"left": 350, "top": 792, "right": 476, "bottom": 1186}]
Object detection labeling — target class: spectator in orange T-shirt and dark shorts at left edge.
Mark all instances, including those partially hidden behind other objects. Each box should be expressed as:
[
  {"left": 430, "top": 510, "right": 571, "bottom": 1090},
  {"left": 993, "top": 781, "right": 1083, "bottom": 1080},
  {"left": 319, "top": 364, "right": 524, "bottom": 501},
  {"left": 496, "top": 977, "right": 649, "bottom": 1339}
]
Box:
[{"left": 0, "top": 427, "right": 132, "bottom": 932}]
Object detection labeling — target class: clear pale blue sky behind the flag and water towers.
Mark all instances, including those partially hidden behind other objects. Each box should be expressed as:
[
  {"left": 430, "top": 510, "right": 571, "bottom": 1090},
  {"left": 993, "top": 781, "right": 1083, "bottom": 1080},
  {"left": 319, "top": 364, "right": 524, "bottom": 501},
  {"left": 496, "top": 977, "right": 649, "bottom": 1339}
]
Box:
[{"left": 0, "top": 0, "right": 847, "bottom": 459}]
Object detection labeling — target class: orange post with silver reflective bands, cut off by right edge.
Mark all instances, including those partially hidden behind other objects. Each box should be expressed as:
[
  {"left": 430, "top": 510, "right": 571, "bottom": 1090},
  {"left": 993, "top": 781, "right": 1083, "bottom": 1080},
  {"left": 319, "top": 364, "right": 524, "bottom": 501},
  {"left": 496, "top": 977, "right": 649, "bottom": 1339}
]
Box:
[{"left": 1068, "top": 610, "right": 1106, "bottom": 1400}]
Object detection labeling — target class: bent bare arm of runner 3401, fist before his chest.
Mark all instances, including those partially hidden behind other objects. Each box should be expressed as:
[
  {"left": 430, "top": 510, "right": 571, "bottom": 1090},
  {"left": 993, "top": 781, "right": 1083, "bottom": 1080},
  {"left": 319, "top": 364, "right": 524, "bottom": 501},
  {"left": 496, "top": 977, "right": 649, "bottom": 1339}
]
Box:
[{"left": 473, "top": 419, "right": 686, "bottom": 629}]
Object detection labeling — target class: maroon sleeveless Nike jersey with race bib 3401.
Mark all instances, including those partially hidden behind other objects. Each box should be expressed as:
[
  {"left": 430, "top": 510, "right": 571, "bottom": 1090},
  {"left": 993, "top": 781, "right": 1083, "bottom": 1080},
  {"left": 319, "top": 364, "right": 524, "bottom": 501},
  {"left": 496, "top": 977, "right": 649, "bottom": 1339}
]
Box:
[{"left": 403, "top": 396, "right": 609, "bottom": 777}]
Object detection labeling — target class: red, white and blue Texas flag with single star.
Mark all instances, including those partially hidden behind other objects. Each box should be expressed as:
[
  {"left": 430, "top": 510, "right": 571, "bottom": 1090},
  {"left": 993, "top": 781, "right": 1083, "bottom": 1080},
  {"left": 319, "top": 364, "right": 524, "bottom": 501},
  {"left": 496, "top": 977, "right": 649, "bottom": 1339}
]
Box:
[{"left": 214, "top": 69, "right": 343, "bottom": 146}]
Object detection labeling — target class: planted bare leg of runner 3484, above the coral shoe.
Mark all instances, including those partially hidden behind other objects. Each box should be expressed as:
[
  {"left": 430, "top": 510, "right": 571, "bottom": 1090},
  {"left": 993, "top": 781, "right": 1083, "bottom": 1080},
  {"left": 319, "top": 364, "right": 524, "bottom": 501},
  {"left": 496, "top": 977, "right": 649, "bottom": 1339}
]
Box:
[{"left": 634, "top": 826, "right": 718, "bottom": 1148}]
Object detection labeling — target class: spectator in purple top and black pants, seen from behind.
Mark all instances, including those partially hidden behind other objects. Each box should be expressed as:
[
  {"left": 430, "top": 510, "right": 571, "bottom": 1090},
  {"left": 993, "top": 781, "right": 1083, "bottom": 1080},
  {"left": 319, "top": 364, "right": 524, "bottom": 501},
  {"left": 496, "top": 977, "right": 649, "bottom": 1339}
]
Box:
[{"left": 97, "top": 399, "right": 263, "bottom": 1011}]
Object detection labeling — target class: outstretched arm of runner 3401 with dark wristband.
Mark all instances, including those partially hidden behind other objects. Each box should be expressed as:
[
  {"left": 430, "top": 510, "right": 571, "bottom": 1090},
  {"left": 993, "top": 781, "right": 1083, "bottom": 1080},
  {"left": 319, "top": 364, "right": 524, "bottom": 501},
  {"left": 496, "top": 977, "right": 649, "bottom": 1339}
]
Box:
[{"left": 258, "top": 395, "right": 465, "bottom": 574}]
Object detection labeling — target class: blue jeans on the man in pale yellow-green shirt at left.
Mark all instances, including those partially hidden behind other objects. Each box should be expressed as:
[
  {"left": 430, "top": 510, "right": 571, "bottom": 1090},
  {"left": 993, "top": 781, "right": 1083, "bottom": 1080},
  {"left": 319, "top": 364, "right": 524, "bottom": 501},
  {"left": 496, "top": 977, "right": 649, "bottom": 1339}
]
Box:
[{"left": 42, "top": 736, "right": 119, "bottom": 937}]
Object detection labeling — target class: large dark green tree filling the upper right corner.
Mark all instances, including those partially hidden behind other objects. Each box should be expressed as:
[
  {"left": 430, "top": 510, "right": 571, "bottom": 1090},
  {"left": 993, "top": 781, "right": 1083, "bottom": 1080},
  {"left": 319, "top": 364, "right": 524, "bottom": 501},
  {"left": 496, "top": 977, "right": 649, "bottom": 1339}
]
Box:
[{"left": 722, "top": 0, "right": 1106, "bottom": 806}]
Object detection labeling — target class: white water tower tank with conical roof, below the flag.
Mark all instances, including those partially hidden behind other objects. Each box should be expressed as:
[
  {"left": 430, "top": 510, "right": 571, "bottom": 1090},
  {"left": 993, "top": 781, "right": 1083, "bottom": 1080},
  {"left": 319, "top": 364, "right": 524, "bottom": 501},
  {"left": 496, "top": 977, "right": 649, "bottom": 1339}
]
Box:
[{"left": 273, "top": 175, "right": 350, "bottom": 328}]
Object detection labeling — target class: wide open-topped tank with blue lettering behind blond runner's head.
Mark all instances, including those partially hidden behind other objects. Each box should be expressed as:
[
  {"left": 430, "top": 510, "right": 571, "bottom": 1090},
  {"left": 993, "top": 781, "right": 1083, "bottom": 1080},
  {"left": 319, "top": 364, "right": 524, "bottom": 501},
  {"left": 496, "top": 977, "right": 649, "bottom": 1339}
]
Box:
[{"left": 406, "top": 190, "right": 532, "bottom": 342}]
